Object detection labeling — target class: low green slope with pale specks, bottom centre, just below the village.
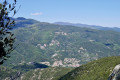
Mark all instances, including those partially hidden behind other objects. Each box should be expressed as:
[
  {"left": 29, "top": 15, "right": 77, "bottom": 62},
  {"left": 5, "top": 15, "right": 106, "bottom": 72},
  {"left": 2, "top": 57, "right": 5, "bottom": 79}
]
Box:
[{"left": 20, "top": 67, "right": 73, "bottom": 80}]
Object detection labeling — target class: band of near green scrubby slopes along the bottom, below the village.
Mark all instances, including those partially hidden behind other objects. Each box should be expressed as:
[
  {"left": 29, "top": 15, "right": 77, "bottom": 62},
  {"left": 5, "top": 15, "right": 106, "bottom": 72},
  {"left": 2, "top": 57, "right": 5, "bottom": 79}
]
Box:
[{"left": 0, "top": 56, "right": 120, "bottom": 80}]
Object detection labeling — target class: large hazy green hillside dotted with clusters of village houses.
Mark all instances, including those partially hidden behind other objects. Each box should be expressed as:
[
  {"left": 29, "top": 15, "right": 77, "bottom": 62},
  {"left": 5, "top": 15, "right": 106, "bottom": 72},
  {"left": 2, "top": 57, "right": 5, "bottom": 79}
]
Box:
[{"left": 4, "top": 18, "right": 120, "bottom": 67}]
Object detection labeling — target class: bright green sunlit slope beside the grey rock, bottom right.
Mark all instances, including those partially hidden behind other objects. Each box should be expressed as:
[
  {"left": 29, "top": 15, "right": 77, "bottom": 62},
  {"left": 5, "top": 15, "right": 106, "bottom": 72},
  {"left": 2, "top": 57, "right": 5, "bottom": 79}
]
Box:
[{"left": 59, "top": 56, "right": 120, "bottom": 80}]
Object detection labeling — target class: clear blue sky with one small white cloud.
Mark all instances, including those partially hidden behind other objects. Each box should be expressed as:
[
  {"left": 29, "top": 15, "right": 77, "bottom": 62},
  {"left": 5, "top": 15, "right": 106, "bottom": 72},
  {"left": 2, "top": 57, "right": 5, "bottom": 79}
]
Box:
[{"left": 10, "top": 0, "right": 120, "bottom": 27}]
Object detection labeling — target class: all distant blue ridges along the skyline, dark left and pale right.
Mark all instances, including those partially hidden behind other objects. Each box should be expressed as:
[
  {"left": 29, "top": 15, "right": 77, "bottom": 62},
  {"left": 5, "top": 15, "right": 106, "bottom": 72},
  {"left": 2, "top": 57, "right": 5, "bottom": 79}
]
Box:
[{"left": 14, "top": 17, "right": 120, "bottom": 32}]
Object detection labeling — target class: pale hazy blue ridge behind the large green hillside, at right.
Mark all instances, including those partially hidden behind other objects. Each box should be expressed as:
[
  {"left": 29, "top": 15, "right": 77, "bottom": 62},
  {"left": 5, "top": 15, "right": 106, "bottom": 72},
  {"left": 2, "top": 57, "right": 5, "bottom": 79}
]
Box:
[{"left": 53, "top": 22, "right": 120, "bottom": 32}]
